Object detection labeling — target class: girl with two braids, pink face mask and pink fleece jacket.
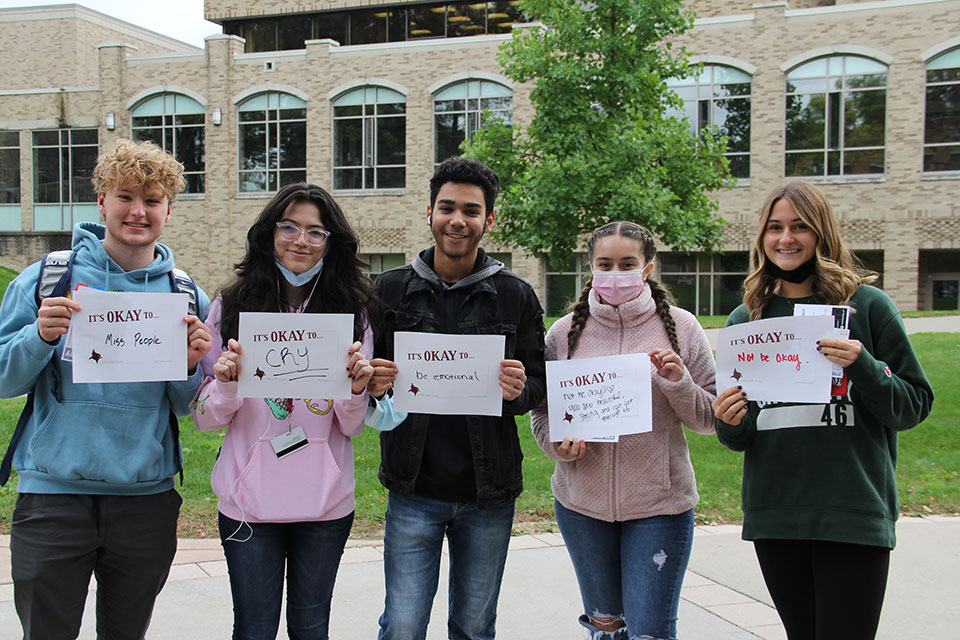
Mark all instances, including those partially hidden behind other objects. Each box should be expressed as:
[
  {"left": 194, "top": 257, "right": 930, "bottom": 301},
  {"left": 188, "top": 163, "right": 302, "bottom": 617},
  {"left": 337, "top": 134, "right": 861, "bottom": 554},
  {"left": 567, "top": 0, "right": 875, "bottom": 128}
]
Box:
[{"left": 531, "top": 222, "right": 716, "bottom": 640}]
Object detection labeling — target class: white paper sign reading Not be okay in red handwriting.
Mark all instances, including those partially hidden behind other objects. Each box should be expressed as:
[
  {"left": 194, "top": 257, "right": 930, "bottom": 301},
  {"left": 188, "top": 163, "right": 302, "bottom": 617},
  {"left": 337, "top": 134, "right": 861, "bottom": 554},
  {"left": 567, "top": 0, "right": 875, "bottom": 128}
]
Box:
[{"left": 717, "top": 316, "right": 833, "bottom": 402}]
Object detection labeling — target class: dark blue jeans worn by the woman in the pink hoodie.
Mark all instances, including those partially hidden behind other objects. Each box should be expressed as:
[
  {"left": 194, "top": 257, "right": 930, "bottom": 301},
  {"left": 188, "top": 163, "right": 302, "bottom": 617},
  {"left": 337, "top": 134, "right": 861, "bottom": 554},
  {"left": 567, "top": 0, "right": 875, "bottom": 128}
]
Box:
[{"left": 219, "top": 513, "right": 353, "bottom": 640}]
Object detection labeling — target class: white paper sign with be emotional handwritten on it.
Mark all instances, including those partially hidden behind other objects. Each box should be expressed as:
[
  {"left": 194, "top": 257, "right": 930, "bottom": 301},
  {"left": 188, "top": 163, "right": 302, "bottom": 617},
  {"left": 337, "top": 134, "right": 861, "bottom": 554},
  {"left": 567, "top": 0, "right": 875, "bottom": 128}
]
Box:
[{"left": 393, "top": 331, "right": 506, "bottom": 416}]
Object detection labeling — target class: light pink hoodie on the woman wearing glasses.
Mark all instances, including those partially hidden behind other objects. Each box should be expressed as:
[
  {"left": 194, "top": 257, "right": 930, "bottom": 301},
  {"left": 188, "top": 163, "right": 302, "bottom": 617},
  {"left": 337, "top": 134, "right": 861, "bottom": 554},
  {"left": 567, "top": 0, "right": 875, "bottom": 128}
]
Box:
[{"left": 191, "top": 296, "right": 373, "bottom": 522}]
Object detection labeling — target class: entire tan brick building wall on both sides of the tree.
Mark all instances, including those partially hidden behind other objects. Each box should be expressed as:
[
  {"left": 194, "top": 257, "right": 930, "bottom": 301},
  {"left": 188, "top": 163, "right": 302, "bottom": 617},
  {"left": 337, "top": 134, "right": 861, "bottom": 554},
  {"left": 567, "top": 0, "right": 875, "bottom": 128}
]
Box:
[{"left": 0, "top": 0, "right": 960, "bottom": 309}]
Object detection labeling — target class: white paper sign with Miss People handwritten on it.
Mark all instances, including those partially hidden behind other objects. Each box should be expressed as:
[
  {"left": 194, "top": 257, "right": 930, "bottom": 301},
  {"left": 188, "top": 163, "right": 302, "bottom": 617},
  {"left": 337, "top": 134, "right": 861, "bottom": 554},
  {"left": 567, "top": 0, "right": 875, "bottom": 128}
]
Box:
[{"left": 70, "top": 287, "right": 187, "bottom": 382}]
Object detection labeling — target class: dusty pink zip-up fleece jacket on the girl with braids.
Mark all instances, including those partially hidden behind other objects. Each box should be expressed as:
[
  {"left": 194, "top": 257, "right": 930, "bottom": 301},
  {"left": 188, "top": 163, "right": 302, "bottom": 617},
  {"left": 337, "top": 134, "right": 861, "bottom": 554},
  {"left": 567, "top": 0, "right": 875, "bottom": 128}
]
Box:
[{"left": 531, "top": 287, "right": 716, "bottom": 522}]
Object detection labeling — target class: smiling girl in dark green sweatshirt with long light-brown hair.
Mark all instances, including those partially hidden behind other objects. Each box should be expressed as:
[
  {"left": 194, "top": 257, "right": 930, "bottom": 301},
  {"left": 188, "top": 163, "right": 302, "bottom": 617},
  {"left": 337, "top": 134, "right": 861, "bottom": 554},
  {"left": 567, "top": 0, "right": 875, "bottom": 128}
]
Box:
[{"left": 713, "top": 182, "right": 933, "bottom": 640}]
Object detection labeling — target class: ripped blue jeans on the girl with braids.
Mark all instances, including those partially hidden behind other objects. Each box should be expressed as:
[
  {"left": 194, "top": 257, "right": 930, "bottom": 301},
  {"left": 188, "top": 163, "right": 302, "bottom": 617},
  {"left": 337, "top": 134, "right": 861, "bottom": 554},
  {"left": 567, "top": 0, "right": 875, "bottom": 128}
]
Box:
[{"left": 554, "top": 501, "right": 693, "bottom": 640}]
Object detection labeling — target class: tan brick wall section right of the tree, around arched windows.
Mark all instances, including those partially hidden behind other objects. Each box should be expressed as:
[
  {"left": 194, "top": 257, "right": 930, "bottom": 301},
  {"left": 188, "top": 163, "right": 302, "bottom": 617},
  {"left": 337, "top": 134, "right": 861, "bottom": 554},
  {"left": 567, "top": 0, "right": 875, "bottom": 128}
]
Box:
[{"left": 681, "top": 2, "right": 960, "bottom": 309}]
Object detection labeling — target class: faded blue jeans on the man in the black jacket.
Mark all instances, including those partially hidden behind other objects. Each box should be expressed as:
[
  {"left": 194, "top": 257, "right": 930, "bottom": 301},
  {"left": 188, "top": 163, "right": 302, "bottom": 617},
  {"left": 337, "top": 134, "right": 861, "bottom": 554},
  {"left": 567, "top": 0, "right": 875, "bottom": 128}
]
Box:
[{"left": 379, "top": 492, "right": 514, "bottom": 640}]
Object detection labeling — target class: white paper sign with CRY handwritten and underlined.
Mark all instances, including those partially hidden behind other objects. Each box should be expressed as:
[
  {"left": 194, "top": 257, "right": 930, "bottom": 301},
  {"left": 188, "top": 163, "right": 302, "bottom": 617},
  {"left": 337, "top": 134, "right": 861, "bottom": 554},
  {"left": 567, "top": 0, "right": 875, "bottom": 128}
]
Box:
[{"left": 237, "top": 312, "right": 353, "bottom": 400}]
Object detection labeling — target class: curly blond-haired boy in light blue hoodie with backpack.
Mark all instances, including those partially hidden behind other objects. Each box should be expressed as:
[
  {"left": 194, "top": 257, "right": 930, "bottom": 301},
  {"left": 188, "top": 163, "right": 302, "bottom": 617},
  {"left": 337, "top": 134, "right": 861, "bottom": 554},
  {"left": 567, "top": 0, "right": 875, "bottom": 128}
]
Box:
[{"left": 0, "top": 140, "right": 212, "bottom": 639}]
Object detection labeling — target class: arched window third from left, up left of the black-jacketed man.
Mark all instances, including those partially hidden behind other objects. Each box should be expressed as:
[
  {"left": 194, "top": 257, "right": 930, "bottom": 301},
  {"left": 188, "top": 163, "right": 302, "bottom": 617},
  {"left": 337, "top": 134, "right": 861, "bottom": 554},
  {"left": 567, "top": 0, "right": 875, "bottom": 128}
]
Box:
[{"left": 333, "top": 87, "right": 407, "bottom": 189}]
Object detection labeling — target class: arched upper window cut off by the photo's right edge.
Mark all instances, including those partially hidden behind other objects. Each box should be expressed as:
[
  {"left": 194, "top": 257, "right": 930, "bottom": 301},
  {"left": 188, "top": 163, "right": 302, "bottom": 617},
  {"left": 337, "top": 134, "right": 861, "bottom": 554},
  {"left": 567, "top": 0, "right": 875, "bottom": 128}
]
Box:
[{"left": 923, "top": 49, "right": 960, "bottom": 171}]
